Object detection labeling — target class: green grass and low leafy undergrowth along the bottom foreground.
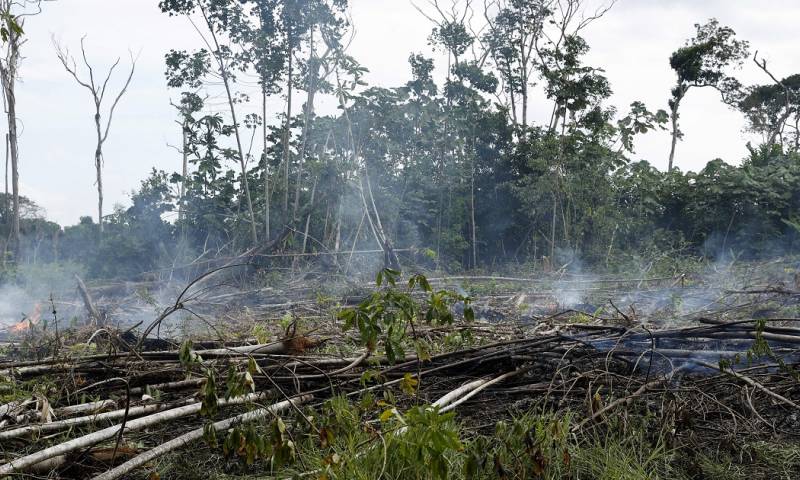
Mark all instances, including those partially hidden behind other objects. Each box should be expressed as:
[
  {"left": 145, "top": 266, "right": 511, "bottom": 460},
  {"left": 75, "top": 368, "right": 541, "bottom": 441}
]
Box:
[{"left": 142, "top": 395, "right": 800, "bottom": 480}]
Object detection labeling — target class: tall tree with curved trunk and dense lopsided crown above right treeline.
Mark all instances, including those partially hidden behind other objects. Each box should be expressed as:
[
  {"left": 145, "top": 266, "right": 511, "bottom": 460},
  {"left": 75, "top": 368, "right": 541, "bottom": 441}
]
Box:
[{"left": 667, "top": 18, "right": 749, "bottom": 170}]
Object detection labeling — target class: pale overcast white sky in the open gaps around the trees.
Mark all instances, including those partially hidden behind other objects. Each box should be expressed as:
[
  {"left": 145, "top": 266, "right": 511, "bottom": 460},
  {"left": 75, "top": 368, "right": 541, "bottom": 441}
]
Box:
[{"left": 10, "top": 0, "right": 800, "bottom": 224}]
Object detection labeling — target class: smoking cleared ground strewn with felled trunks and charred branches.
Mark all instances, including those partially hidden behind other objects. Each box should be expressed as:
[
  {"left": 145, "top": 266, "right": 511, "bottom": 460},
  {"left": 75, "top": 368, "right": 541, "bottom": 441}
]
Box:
[{"left": 0, "top": 262, "right": 800, "bottom": 478}]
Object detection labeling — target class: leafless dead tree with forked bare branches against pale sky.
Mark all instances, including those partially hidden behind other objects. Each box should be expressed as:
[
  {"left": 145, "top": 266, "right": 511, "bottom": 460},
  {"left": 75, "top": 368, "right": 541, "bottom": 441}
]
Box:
[{"left": 53, "top": 36, "right": 136, "bottom": 236}]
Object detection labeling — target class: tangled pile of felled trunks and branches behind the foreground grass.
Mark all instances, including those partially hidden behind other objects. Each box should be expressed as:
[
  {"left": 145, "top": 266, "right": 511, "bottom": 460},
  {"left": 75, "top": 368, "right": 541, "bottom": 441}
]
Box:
[{"left": 0, "top": 310, "right": 800, "bottom": 479}]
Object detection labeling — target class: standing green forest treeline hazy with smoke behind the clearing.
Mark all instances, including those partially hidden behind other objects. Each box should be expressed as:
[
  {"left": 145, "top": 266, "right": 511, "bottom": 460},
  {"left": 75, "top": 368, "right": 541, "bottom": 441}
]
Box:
[{"left": 0, "top": 0, "right": 800, "bottom": 278}]
